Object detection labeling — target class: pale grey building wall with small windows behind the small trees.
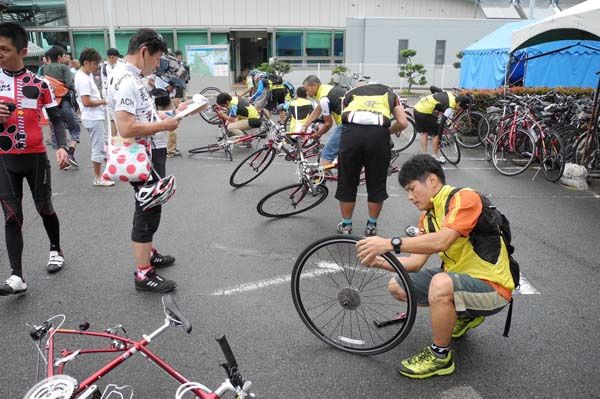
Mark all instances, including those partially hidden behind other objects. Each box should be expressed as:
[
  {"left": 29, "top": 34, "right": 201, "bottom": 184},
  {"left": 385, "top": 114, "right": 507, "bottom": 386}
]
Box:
[{"left": 346, "top": 18, "right": 512, "bottom": 87}]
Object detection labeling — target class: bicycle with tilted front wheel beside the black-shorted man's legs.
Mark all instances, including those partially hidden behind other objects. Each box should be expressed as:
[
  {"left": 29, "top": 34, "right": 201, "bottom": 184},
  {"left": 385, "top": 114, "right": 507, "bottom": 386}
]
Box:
[{"left": 256, "top": 133, "right": 401, "bottom": 218}]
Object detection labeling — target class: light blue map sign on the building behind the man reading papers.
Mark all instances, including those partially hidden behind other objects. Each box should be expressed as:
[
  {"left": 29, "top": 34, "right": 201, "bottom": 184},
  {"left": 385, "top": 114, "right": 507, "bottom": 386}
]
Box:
[{"left": 185, "top": 45, "right": 229, "bottom": 76}]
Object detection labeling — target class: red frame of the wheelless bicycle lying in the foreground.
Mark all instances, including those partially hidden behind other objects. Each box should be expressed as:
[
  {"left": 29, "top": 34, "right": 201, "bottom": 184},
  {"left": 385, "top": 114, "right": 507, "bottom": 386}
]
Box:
[{"left": 45, "top": 318, "right": 235, "bottom": 399}]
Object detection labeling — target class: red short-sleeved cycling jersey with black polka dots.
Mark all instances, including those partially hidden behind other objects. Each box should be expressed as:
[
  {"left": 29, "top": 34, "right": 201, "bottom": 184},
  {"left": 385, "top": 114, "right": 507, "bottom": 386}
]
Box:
[{"left": 0, "top": 69, "right": 57, "bottom": 155}]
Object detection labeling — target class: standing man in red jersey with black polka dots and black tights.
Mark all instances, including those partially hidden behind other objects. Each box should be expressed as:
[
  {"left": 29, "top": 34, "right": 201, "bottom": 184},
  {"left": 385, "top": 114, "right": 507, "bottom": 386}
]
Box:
[{"left": 0, "top": 22, "right": 69, "bottom": 295}]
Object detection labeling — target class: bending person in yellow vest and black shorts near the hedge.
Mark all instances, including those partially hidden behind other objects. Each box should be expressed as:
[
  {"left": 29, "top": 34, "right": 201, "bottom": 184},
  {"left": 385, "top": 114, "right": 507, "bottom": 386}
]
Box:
[{"left": 414, "top": 90, "right": 471, "bottom": 163}]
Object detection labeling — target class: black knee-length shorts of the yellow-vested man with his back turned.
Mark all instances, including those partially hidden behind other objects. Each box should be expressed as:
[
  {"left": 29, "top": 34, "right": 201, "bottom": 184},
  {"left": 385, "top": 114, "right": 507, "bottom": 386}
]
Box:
[{"left": 335, "top": 124, "right": 391, "bottom": 203}]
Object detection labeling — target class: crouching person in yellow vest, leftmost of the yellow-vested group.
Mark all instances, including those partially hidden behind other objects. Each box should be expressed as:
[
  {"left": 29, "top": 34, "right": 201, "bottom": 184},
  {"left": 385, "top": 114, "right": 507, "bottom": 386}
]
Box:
[{"left": 217, "top": 93, "right": 260, "bottom": 140}]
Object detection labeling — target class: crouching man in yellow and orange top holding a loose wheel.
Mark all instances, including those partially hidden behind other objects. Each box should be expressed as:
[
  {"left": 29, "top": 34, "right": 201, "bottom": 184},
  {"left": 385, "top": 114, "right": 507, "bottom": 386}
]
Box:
[{"left": 356, "top": 154, "right": 515, "bottom": 378}]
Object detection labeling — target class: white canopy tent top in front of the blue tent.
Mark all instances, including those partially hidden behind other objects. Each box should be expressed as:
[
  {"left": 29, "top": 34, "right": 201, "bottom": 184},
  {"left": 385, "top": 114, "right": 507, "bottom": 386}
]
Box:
[{"left": 510, "top": 0, "right": 600, "bottom": 53}]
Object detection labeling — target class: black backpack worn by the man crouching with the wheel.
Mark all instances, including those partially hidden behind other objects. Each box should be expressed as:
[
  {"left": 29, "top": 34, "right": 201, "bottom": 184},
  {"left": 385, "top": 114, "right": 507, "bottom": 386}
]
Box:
[{"left": 444, "top": 187, "right": 521, "bottom": 337}]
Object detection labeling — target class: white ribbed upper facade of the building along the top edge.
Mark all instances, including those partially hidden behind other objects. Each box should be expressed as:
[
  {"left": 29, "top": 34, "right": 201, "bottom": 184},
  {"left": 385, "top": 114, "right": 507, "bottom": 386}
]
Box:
[{"left": 66, "top": 0, "right": 483, "bottom": 30}]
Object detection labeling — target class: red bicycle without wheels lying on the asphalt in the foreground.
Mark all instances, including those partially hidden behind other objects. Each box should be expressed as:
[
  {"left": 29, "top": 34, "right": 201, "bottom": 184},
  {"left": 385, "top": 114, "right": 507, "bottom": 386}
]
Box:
[{"left": 24, "top": 295, "right": 254, "bottom": 399}]
